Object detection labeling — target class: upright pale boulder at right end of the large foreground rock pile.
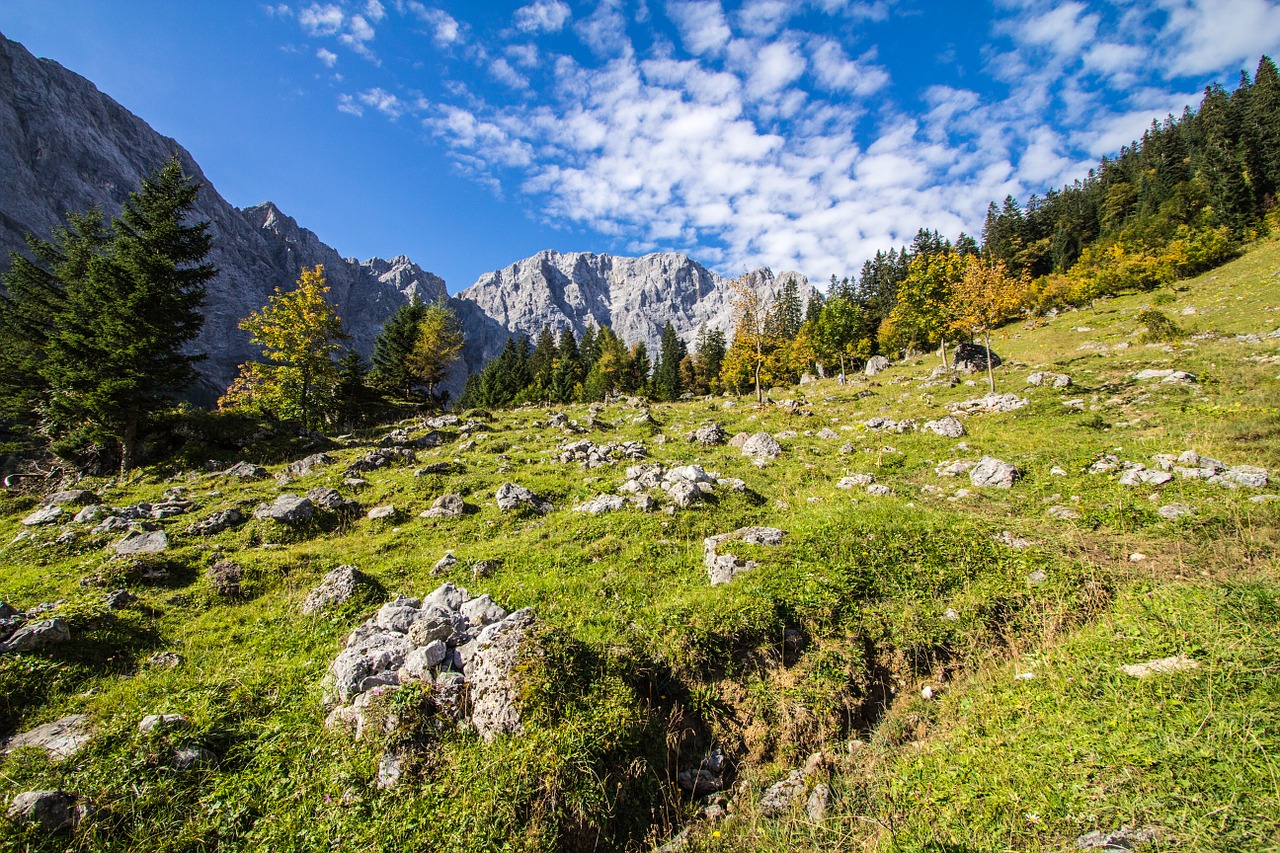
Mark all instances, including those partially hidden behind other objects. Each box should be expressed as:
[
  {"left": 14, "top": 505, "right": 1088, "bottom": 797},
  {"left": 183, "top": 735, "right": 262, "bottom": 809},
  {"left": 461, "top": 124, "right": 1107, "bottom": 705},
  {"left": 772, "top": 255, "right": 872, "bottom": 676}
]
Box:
[{"left": 467, "top": 608, "right": 535, "bottom": 740}]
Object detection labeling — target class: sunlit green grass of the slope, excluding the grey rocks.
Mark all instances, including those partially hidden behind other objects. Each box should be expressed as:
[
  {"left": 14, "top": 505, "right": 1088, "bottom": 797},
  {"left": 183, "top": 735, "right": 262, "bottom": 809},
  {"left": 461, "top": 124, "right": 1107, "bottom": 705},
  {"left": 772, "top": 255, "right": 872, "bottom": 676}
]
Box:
[{"left": 0, "top": 234, "right": 1280, "bottom": 850}]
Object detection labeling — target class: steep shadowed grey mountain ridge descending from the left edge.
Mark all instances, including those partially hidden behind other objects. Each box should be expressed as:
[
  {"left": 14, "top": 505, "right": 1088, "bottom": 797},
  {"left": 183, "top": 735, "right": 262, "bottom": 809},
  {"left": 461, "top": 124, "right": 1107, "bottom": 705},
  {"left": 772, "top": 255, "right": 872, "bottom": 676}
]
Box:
[{"left": 0, "top": 36, "right": 448, "bottom": 402}]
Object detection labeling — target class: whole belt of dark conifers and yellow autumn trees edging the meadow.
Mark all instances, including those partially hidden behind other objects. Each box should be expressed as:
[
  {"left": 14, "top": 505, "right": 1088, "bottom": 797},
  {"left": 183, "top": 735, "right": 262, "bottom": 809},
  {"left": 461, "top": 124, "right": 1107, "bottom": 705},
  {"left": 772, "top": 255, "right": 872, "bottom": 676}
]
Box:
[{"left": 0, "top": 56, "right": 1280, "bottom": 470}]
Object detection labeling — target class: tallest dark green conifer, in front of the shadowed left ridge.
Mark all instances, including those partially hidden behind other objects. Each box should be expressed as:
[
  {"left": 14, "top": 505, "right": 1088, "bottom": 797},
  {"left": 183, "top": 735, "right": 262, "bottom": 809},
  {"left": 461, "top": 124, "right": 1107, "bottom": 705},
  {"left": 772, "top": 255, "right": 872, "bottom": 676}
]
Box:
[{"left": 41, "top": 158, "right": 218, "bottom": 474}]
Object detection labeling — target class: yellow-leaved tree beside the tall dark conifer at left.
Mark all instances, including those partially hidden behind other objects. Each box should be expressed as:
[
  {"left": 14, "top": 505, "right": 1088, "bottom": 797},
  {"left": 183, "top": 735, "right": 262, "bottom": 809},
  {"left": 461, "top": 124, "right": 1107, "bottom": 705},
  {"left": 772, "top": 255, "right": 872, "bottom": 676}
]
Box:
[{"left": 218, "top": 265, "right": 347, "bottom": 429}]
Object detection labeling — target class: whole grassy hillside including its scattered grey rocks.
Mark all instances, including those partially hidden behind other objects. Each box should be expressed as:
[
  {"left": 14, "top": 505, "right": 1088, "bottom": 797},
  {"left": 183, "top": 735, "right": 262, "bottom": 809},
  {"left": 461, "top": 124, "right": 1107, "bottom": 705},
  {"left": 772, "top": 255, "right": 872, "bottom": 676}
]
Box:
[{"left": 0, "top": 240, "right": 1280, "bottom": 850}]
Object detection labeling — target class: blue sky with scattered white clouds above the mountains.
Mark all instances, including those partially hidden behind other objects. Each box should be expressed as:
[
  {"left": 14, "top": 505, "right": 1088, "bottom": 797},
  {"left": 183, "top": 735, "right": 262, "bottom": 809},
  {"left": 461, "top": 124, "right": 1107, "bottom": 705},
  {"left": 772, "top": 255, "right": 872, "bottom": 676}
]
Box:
[{"left": 0, "top": 0, "right": 1280, "bottom": 292}]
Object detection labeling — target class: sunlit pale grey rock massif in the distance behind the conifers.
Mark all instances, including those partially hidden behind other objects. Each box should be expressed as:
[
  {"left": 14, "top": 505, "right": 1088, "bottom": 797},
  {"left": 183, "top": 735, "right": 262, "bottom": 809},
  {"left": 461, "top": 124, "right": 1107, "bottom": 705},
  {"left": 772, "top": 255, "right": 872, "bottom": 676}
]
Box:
[{"left": 454, "top": 245, "right": 813, "bottom": 369}]
